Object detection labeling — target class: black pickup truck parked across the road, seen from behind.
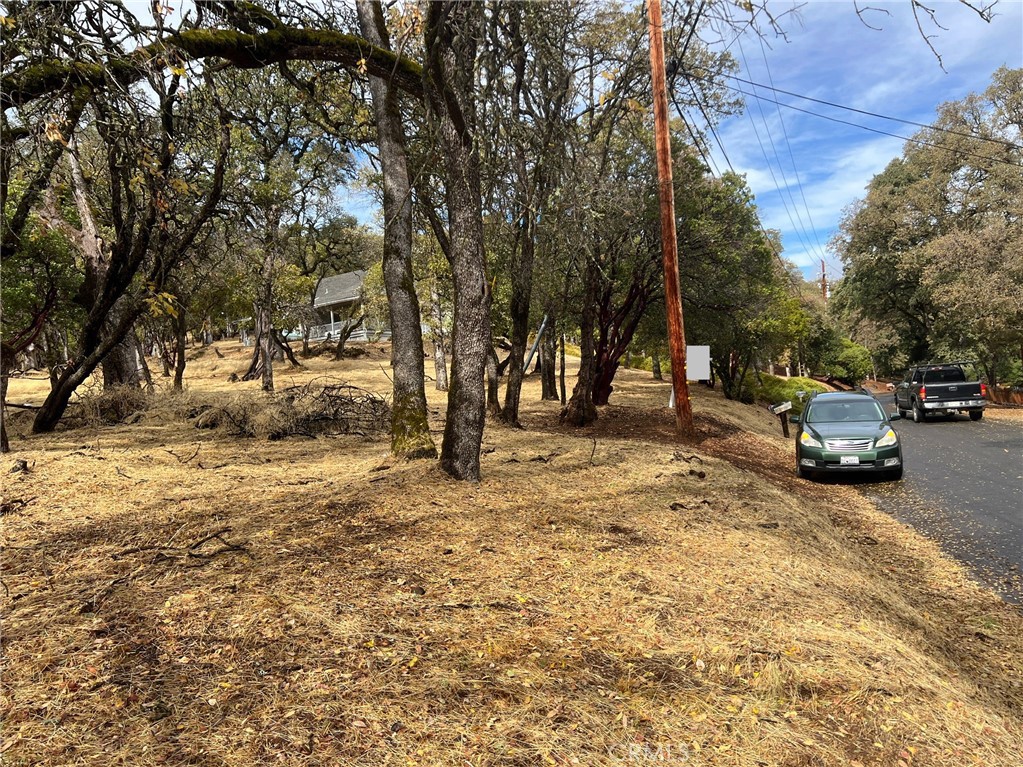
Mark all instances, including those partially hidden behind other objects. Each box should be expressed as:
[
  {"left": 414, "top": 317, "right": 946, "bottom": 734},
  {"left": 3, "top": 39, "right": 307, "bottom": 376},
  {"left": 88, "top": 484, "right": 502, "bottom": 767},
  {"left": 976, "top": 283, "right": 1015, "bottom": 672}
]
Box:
[{"left": 895, "top": 362, "right": 987, "bottom": 423}]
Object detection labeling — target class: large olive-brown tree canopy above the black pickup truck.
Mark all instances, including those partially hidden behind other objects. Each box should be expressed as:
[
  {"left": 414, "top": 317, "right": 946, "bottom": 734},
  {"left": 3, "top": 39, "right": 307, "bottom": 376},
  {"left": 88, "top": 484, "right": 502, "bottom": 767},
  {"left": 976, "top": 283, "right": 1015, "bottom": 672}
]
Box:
[{"left": 835, "top": 67, "right": 1023, "bottom": 374}]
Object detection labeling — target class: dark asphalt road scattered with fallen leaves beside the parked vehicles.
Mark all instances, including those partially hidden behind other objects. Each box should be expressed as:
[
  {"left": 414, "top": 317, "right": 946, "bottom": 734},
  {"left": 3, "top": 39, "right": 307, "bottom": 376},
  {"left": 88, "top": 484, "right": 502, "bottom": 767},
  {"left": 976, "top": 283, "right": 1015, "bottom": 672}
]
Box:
[{"left": 861, "top": 395, "right": 1023, "bottom": 604}]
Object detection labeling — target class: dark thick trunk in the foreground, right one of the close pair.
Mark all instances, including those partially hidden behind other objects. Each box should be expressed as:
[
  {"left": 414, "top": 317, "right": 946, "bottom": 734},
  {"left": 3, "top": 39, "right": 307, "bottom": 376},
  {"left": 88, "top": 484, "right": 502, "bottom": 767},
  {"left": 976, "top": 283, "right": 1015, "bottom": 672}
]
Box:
[{"left": 425, "top": 3, "right": 490, "bottom": 482}]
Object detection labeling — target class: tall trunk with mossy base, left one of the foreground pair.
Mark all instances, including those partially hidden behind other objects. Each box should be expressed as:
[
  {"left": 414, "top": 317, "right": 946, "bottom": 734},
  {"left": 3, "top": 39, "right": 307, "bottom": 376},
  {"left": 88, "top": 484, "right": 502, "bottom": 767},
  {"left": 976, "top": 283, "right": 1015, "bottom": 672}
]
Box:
[{"left": 356, "top": 0, "right": 435, "bottom": 458}]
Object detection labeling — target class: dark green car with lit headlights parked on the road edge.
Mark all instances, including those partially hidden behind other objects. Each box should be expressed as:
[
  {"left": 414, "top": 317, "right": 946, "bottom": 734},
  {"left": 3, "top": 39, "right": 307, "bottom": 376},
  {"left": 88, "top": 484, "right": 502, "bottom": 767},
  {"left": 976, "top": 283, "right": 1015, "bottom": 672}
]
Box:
[{"left": 790, "top": 392, "right": 902, "bottom": 480}]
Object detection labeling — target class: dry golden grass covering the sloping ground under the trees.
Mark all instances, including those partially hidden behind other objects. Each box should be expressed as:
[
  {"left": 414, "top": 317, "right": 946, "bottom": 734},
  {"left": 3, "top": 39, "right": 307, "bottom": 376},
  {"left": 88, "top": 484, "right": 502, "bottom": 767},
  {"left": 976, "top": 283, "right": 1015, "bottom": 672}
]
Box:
[{"left": 6, "top": 345, "right": 1023, "bottom": 767}]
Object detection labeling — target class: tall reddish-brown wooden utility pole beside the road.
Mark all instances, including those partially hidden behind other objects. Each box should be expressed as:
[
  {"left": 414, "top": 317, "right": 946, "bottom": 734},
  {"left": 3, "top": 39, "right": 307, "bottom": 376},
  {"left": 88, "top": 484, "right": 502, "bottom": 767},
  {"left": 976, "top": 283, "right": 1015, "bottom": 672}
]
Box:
[{"left": 647, "top": 0, "right": 696, "bottom": 438}]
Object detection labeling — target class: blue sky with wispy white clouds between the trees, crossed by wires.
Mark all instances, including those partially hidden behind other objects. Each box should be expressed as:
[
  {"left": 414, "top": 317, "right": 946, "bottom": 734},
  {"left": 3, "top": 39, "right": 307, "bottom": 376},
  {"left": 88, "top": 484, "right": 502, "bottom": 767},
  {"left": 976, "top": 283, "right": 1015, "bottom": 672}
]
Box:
[{"left": 699, "top": 0, "right": 1023, "bottom": 277}]
